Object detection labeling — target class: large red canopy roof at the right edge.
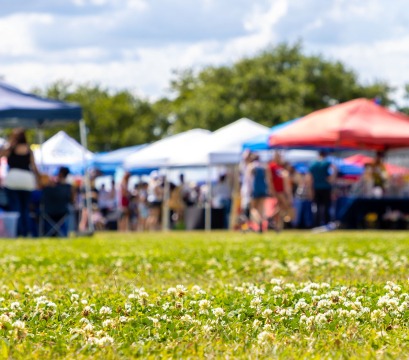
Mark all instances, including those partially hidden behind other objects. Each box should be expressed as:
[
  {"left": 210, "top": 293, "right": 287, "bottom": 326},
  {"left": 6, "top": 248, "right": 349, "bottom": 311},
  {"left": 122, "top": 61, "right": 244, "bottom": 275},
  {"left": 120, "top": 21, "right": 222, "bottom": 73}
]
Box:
[{"left": 269, "top": 99, "right": 409, "bottom": 150}]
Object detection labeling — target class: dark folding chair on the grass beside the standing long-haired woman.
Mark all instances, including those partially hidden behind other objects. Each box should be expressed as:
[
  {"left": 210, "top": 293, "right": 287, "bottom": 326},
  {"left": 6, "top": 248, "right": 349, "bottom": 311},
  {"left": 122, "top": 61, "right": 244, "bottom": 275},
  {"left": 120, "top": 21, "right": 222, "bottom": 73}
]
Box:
[{"left": 39, "top": 184, "right": 72, "bottom": 237}]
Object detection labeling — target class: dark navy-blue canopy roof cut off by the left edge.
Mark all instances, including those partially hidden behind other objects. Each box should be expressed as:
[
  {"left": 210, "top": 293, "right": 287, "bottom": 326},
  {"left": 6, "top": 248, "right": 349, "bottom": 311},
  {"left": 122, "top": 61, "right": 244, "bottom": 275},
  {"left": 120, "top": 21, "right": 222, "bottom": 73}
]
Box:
[{"left": 0, "top": 81, "right": 82, "bottom": 127}]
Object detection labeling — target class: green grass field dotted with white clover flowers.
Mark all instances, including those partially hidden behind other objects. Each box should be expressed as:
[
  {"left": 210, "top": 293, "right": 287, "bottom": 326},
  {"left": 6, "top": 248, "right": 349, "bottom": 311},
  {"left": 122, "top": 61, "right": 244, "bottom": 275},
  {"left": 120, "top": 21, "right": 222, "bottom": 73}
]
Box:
[{"left": 0, "top": 231, "right": 409, "bottom": 359}]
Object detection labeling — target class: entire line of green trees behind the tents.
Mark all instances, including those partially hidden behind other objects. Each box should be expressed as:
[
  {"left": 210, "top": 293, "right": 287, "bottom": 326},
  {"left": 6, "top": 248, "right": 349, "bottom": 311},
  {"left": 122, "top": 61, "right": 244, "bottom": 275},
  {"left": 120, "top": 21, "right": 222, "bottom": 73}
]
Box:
[{"left": 34, "top": 43, "right": 409, "bottom": 151}]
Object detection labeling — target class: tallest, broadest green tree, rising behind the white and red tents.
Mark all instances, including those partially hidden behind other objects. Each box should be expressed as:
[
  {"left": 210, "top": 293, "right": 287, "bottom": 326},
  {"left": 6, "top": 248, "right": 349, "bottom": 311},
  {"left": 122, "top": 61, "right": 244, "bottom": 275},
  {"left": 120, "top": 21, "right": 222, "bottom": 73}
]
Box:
[{"left": 171, "top": 43, "right": 392, "bottom": 132}]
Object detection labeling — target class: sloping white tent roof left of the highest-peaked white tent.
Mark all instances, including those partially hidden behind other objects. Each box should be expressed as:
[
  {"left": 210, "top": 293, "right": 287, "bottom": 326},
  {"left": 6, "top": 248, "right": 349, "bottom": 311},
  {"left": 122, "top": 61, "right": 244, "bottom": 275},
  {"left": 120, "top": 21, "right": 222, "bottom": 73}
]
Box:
[{"left": 123, "top": 129, "right": 211, "bottom": 170}]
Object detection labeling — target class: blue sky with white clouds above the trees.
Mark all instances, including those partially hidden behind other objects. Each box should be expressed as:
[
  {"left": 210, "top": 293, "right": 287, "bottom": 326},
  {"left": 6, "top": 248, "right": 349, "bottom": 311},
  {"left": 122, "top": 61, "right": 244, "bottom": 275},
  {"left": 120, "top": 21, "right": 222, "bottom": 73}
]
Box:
[{"left": 0, "top": 0, "right": 409, "bottom": 98}]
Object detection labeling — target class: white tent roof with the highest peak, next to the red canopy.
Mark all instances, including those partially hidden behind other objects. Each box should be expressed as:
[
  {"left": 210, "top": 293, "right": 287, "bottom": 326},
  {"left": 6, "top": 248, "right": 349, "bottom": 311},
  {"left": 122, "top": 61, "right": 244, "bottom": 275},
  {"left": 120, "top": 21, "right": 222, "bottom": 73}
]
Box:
[{"left": 171, "top": 118, "right": 270, "bottom": 167}]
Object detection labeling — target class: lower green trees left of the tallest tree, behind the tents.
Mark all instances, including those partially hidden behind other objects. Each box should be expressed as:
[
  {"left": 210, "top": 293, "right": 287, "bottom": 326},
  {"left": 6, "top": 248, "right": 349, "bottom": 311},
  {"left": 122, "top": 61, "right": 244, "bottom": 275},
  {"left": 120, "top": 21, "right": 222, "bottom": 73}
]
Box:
[{"left": 36, "top": 81, "right": 166, "bottom": 151}]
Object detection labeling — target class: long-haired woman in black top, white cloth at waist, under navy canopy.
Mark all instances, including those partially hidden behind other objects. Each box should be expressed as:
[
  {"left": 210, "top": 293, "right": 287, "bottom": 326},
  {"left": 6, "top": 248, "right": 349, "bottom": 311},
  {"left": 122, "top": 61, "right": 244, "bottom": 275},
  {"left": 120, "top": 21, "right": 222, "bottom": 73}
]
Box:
[{"left": 0, "top": 128, "right": 39, "bottom": 237}]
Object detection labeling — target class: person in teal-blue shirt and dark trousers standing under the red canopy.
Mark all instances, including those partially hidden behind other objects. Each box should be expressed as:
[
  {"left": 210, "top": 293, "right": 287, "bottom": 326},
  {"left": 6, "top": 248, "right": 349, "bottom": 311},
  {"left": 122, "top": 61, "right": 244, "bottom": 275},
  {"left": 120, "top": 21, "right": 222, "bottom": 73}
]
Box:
[{"left": 309, "top": 151, "right": 336, "bottom": 226}]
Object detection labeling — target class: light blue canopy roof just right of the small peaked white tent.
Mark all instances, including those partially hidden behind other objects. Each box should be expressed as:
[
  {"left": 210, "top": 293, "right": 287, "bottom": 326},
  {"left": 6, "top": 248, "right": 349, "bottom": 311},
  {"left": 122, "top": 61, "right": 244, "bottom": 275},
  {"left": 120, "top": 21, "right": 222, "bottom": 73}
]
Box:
[{"left": 91, "top": 144, "right": 150, "bottom": 175}]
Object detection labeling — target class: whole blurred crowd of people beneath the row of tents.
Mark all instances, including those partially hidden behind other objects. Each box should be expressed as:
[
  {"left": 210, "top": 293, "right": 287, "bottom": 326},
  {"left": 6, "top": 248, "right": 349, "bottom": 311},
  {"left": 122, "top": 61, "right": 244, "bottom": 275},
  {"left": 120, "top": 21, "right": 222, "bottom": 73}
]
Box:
[{"left": 0, "top": 129, "right": 402, "bottom": 237}]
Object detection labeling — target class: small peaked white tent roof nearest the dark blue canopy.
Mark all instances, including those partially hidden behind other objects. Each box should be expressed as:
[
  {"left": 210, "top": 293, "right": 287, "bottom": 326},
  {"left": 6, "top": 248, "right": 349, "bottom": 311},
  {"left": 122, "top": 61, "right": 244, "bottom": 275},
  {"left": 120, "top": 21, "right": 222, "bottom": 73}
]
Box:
[{"left": 34, "top": 131, "right": 93, "bottom": 166}]
